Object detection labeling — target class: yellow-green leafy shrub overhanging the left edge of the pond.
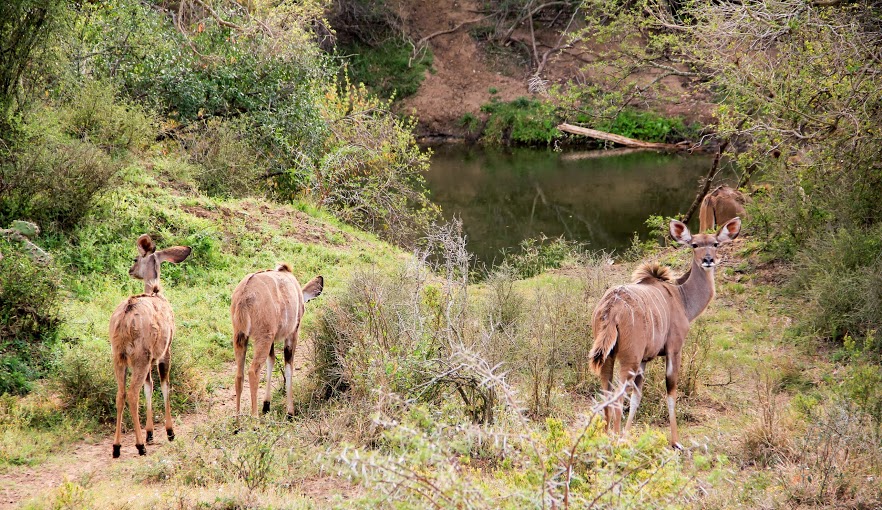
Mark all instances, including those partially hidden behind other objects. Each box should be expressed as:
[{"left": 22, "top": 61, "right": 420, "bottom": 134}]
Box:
[{"left": 286, "top": 82, "right": 439, "bottom": 244}]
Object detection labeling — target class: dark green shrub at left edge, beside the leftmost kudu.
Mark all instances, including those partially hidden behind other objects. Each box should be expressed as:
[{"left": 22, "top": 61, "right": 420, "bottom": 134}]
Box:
[{"left": 0, "top": 237, "right": 61, "bottom": 394}]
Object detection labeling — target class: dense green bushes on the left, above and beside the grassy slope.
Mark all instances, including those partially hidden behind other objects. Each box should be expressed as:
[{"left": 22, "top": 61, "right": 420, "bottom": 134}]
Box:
[{"left": 0, "top": 0, "right": 438, "bottom": 394}]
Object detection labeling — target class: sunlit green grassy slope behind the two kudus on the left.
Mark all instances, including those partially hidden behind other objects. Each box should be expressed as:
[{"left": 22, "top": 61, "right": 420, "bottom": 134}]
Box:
[{"left": 0, "top": 159, "right": 405, "bottom": 490}]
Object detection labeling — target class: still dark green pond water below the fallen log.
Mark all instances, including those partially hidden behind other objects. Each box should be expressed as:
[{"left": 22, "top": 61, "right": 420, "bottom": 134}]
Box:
[{"left": 426, "top": 145, "right": 710, "bottom": 263}]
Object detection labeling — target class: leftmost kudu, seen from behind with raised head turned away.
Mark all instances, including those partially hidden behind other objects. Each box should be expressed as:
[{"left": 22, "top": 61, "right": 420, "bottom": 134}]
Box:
[{"left": 110, "top": 234, "right": 190, "bottom": 458}]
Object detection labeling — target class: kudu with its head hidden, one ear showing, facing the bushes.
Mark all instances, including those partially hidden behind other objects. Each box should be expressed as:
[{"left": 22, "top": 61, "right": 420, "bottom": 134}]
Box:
[{"left": 230, "top": 264, "right": 324, "bottom": 417}]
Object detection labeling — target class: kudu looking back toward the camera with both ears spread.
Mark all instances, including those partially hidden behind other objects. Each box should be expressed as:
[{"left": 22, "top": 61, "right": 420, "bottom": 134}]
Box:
[{"left": 589, "top": 218, "right": 741, "bottom": 448}]
